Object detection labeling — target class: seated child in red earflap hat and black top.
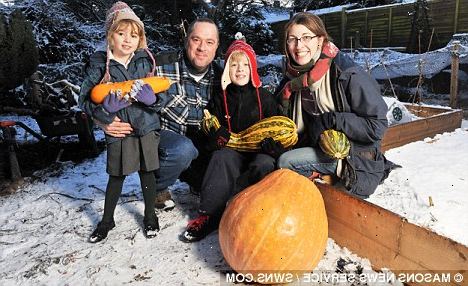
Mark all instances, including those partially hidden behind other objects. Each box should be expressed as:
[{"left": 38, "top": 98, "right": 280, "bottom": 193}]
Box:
[{"left": 181, "top": 35, "right": 283, "bottom": 242}]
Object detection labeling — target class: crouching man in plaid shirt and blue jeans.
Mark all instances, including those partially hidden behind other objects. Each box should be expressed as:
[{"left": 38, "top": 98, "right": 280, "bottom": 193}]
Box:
[{"left": 99, "top": 19, "right": 220, "bottom": 210}]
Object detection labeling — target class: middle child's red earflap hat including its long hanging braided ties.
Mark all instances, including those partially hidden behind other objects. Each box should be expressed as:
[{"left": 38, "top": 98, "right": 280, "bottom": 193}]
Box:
[{"left": 221, "top": 40, "right": 263, "bottom": 131}]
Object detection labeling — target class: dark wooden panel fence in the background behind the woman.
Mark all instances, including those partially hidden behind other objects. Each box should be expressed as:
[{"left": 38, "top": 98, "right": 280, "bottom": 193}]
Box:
[{"left": 266, "top": 0, "right": 468, "bottom": 50}]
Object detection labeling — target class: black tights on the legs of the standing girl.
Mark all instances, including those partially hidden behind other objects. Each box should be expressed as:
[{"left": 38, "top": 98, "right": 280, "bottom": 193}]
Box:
[{"left": 102, "top": 171, "right": 156, "bottom": 223}]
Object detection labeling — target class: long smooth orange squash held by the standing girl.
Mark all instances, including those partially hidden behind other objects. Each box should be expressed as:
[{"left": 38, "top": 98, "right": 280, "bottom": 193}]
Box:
[{"left": 91, "top": 76, "right": 173, "bottom": 104}]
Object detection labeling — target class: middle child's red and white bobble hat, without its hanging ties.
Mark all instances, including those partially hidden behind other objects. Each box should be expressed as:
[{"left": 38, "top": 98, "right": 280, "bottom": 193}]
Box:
[{"left": 221, "top": 37, "right": 262, "bottom": 90}]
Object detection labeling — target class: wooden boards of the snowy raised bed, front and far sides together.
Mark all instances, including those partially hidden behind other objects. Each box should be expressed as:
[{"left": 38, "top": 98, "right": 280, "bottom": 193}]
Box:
[{"left": 317, "top": 105, "right": 468, "bottom": 285}]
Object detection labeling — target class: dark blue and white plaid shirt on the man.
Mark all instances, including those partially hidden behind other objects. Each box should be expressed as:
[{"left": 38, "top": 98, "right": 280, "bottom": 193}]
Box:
[{"left": 156, "top": 52, "right": 216, "bottom": 135}]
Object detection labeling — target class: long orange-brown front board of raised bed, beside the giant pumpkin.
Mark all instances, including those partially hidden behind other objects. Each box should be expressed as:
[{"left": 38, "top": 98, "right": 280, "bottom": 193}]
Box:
[{"left": 317, "top": 184, "right": 468, "bottom": 285}]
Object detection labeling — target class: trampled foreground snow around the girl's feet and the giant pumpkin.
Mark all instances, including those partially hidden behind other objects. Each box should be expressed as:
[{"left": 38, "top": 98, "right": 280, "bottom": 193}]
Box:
[{"left": 0, "top": 131, "right": 384, "bottom": 285}]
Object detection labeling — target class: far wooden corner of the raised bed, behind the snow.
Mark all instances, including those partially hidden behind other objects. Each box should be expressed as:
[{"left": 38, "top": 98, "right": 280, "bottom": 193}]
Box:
[{"left": 382, "top": 104, "right": 463, "bottom": 151}]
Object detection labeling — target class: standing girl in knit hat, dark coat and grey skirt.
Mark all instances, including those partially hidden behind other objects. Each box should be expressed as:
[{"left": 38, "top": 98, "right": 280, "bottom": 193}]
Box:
[{"left": 80, "top": 2, "right": 160, "bottom": 243}]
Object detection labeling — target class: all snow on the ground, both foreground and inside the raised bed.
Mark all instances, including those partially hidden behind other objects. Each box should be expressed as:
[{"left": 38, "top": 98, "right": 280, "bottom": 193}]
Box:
[{"left": 0, "top": 114, "right": 468, "bottom": 285}]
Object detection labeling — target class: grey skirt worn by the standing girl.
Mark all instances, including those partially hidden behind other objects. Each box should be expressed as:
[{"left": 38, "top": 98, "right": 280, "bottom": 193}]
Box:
[{"left": 107, "top": 131, "right": 159, "bottom": 176}]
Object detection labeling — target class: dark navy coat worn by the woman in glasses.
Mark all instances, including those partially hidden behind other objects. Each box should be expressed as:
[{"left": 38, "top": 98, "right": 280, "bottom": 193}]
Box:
[{"left": 278, "top": 52, "right": 395, "bottom": 198}]
